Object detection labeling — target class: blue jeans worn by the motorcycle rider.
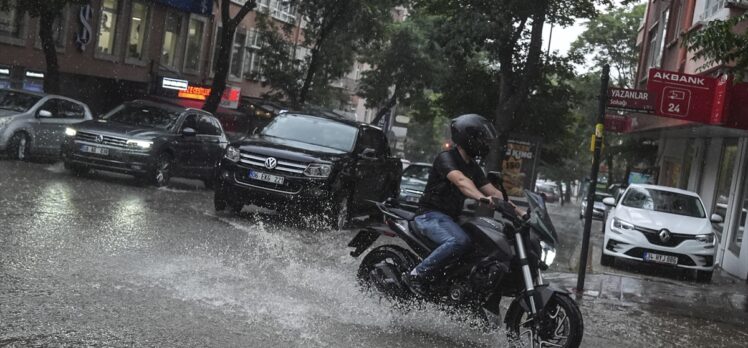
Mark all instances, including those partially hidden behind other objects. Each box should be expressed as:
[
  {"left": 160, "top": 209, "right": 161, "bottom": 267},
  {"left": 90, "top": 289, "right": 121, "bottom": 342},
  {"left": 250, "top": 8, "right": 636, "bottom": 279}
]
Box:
[{"left": 415, "top": 211, "right": 471, "bottom": 277}]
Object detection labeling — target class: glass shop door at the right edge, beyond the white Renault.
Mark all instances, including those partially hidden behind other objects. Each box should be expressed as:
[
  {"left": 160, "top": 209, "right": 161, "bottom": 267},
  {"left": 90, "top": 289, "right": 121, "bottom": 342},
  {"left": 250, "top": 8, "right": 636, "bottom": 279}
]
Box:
[{"left": 722, "top": 139, "right": 748, "bottom": 279}]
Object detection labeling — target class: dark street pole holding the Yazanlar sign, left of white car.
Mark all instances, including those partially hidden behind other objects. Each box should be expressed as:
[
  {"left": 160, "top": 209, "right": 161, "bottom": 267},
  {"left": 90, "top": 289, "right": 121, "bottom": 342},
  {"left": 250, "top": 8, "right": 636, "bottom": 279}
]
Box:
[{"left": 577, "top": 64, "right": 610, "bottom": 293}]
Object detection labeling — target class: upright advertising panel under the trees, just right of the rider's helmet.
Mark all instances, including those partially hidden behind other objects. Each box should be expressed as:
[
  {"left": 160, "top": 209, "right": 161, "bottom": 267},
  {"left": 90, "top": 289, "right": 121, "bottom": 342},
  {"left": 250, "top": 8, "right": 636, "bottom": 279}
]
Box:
[{"left": 501, "top": 139, "right": 540, "bottom": 197}]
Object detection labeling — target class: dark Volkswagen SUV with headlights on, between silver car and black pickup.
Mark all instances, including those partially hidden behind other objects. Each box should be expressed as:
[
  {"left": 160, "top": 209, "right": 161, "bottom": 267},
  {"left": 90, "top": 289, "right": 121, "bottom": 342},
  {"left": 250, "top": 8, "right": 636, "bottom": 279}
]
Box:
[{"left": 62, "top": 100, "right": 228, "bottom": 186}]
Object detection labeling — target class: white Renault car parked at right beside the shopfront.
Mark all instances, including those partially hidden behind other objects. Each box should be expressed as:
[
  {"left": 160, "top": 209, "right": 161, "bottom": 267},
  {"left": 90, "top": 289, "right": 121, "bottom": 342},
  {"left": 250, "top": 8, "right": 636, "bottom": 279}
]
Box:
[{"left": 600, "top": 184, "right": 722, "bottom": 282}]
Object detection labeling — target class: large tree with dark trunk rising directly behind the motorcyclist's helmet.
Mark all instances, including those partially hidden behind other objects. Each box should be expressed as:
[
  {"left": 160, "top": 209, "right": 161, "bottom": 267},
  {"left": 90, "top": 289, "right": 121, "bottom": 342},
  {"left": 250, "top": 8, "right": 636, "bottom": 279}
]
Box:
[{"left": 417, "top": 0, "right": 608, "bottom": 170}]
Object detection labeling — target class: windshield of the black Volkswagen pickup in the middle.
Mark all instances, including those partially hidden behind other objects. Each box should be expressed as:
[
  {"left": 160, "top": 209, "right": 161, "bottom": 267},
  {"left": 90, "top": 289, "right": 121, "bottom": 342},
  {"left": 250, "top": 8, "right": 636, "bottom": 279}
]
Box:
[{"left": 260, "top": 114, "right": 358, "bottom": 152}]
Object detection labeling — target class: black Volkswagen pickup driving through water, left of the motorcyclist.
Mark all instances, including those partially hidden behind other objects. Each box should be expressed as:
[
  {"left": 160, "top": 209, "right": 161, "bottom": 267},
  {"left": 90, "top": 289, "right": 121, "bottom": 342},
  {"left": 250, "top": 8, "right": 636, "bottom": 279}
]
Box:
[{"left": 215, "top": 113, "right": 402, "bottom": 228}]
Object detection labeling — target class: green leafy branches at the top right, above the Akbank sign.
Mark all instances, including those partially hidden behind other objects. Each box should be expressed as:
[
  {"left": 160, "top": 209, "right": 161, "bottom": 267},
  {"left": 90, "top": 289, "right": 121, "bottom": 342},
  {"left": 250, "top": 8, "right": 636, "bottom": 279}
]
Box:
[{"left": 684, "top": 13, "right": 748, "bottom": 81}]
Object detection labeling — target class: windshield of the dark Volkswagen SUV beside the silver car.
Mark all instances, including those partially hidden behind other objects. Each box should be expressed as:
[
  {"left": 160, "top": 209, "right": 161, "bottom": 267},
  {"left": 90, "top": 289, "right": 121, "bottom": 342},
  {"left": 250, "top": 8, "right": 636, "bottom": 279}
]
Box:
[{"left": 101, "top": 104, "right": 179, "bottom": 130}]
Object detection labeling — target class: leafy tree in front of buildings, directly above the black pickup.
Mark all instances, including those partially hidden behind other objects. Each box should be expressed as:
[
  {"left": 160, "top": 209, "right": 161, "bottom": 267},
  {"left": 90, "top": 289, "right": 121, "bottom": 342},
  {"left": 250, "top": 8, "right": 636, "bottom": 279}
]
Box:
[{"left": 254, "top": 0, "right": 401, "bottom": 107}]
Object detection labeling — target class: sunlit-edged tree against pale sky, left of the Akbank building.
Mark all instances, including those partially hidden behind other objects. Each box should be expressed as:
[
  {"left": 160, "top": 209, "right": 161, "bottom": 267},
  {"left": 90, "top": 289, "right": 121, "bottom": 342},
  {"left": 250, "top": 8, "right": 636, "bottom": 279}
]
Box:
[{"left": 571, "top": 4, "right": 646, "bottom": 88}]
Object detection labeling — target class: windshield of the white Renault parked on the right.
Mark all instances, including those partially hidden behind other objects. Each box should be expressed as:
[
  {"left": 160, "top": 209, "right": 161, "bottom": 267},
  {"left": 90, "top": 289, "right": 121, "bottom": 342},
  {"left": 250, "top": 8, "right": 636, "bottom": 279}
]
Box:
[{"left": 622, "top": 187, "right": 706, "bottom": 218}]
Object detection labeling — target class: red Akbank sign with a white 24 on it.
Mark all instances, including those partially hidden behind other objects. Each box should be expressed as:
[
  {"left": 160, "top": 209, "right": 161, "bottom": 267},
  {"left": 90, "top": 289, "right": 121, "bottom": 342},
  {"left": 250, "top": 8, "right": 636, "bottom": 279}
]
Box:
[{"left": 647, "top": 69, "right": 717, "bottom": 124}]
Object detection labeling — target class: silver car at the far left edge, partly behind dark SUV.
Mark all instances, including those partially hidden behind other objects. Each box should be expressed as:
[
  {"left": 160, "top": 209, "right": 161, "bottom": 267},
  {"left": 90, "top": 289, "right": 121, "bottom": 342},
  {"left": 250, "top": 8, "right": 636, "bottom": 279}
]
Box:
[{"left": 0, "top": 89, "right": 93, "bottom": 160}]
